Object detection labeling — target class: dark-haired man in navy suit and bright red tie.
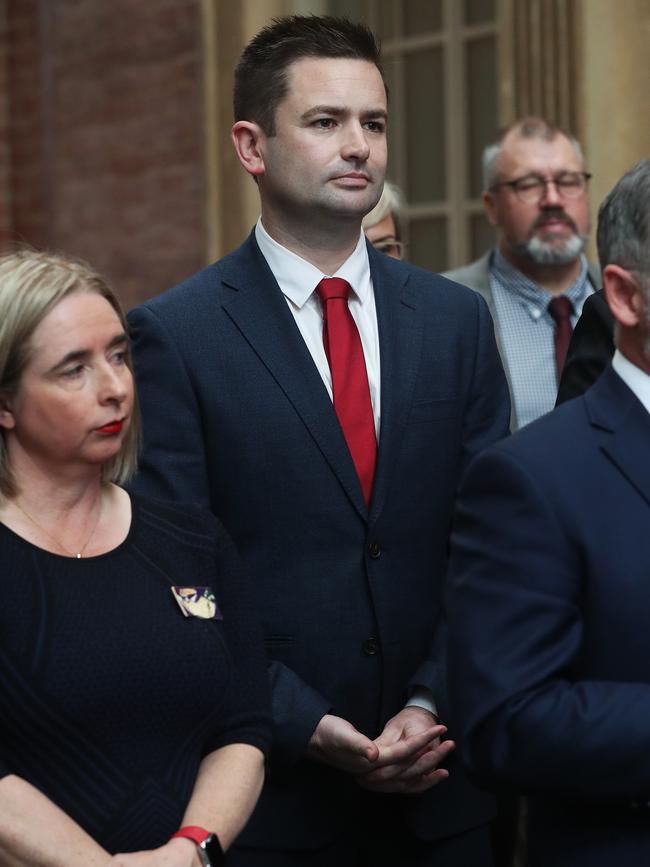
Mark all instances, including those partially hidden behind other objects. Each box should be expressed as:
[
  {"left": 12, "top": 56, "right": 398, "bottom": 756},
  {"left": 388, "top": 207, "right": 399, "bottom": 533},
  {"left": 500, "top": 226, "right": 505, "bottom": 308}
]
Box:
[{"left": 130, "top": 16, "right": 509, "bottom": 867}]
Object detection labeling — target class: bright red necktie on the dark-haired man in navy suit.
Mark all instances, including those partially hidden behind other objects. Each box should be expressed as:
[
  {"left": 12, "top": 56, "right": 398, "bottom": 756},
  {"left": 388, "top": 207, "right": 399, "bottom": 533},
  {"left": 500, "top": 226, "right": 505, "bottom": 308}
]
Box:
[{"left": 316, "top": 277, "right": 377, "bottom": 505}]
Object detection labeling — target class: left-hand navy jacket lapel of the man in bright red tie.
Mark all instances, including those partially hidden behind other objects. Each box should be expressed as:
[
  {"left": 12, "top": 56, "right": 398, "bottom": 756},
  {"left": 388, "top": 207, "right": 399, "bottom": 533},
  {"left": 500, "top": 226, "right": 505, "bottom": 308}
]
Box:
[{"left": 222, "top": 234, "right": 367, "bottom": 519}]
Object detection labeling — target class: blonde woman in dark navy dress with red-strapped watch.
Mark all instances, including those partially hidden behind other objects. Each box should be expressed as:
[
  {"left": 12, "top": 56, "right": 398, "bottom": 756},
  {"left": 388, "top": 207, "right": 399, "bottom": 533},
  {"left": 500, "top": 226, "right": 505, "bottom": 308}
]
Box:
[{"left": 0, "top": 251, "right": 268, "bottom": 867}]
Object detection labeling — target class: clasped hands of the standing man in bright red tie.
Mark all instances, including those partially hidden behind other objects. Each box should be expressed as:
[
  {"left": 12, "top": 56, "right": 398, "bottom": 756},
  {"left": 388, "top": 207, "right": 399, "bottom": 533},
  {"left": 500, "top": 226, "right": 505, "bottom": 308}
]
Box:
[{"left": 307, "top": 706, "right": 455, "bottom": 794}]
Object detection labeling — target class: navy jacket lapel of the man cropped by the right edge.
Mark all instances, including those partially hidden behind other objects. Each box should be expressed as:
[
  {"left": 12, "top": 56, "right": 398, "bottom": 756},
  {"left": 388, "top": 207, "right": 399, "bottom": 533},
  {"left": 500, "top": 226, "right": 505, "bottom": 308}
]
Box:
[{"left": 585, "top": 365, "right": 650, "bottom": 505}]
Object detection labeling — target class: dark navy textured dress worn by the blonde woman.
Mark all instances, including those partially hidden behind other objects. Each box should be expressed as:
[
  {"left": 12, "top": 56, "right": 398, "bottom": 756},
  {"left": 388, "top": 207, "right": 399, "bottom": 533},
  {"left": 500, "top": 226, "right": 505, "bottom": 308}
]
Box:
[{"left": 0, "top": 496, "right": 269, "bottom": 853}]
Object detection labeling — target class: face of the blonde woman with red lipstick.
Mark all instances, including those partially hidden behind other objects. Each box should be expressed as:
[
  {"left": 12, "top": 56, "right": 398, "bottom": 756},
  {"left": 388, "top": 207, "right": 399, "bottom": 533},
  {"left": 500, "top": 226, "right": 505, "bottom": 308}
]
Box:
[{"left": 0, "top": 292, "right": 133, "bottom": 471}]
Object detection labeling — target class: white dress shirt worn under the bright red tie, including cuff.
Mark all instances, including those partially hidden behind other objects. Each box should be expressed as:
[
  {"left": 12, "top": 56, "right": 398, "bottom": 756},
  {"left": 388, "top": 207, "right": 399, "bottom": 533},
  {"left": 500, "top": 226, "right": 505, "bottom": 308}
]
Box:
[{"left": 255, "top": 217, "right": 436, "bottom": 714}]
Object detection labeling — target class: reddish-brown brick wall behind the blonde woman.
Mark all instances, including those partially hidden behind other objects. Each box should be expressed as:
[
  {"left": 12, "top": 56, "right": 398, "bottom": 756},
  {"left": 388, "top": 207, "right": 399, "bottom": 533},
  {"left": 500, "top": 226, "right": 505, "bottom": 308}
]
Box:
[{"left": 0, "top": 0, "right": 205, "bottom": 307}]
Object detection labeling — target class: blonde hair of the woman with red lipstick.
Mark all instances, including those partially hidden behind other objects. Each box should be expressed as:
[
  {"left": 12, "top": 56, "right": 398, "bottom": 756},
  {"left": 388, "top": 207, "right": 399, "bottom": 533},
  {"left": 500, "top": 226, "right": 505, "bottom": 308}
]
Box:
[{"left": 0, "top": 249, "right": 141, "bottom": 497}]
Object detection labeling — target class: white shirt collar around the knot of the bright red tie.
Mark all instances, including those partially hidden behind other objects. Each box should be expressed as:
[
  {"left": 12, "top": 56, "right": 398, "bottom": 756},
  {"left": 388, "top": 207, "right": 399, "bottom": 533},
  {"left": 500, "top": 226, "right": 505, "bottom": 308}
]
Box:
[{"left": 255, "top": 217, "right": 370, "bottom": 308}]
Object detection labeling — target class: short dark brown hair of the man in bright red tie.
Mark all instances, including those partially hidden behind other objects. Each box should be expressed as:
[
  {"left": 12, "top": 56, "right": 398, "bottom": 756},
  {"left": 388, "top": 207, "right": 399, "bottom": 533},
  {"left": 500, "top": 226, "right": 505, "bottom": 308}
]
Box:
[{"left": 234, "top": 15, "right": 383, "bottom": 135}]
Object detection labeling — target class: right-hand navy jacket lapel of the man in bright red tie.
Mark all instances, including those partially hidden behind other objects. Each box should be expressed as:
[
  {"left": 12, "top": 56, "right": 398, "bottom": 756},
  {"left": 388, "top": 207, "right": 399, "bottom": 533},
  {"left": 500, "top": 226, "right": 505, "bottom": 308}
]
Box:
[{"left": 368, "top": 245, "right": 423, "bottom": 521}]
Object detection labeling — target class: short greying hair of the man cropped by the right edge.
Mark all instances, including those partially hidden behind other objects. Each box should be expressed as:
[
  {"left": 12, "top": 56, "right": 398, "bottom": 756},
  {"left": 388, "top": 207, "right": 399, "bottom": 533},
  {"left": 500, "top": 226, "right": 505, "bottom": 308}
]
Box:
[{"left": 597, "top": 157, "right": 650, "bottom": 278}]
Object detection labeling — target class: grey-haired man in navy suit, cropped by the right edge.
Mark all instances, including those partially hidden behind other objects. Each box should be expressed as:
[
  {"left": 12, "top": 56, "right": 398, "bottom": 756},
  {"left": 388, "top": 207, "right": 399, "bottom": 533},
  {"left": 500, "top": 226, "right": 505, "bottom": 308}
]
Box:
[{"left": 449, "top": 159, "right": 650, "bottom": 867}]
